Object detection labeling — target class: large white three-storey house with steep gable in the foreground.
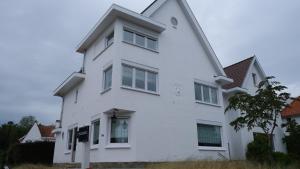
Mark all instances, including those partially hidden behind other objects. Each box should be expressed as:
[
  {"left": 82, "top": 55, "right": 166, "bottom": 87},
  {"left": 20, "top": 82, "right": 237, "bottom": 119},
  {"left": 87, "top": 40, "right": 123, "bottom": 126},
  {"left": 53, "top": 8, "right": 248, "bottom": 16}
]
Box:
[{"left": 54, "top": 0, "right": 232, "bottom": 163}]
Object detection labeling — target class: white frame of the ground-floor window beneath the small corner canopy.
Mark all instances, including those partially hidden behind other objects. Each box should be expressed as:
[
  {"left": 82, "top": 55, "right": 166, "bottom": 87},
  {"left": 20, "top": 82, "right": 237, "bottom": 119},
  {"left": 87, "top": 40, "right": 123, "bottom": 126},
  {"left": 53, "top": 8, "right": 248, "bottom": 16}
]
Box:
[{"left": 105, "top": 115, "right": 131, "bottom": 149}]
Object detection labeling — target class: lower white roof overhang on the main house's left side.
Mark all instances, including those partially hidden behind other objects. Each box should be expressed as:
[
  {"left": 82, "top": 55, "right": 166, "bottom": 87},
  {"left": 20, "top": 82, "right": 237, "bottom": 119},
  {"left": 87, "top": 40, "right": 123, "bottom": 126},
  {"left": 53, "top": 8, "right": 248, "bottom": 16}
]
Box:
[{"left": 54, "top": 72, "right": 85, "bottom": 96}]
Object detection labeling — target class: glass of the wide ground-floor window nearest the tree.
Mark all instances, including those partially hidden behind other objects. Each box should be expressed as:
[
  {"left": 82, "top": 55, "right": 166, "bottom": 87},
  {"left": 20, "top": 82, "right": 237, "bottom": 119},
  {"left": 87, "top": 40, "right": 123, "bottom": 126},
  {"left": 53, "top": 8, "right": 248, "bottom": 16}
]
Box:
[{"left": 197, "top": 124, "right": 222, "bottom": 147}]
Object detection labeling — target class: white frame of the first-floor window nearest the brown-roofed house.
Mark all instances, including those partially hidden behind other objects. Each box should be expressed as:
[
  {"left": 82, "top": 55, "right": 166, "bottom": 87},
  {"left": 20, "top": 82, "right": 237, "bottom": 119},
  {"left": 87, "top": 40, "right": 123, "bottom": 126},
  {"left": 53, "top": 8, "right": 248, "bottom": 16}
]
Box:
[{"left": 193, "top": 79, "right": 221, "bottom": 106}]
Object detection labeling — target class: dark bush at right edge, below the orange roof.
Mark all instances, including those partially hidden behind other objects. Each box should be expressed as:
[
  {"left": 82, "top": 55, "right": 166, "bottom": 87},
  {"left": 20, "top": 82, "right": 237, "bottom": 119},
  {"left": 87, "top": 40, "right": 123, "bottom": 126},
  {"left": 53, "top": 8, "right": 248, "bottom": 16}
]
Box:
[{"left": 283, "top": 119, "right": 300, "bottom": 162}]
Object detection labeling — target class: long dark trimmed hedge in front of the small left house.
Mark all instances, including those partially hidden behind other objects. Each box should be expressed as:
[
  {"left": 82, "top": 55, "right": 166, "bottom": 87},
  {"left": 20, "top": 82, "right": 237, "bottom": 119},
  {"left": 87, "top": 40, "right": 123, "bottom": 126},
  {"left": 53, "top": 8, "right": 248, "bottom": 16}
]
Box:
[{"left": 7, "top": 142, "right": 54, "bottom": 165}]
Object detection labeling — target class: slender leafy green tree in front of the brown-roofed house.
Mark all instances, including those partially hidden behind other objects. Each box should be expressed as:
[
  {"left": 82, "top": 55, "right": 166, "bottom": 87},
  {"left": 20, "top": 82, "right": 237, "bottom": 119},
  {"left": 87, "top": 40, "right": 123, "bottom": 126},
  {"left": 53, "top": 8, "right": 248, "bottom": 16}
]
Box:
[{"left": 225, "top": 77, "right": 290, "bottom": 161}]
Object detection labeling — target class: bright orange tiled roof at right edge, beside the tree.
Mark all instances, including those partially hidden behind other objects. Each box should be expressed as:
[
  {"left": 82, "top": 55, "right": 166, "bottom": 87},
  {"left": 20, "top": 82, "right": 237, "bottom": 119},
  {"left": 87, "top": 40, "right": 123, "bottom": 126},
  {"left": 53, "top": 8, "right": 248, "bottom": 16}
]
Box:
[{"left": 281, "top": 96, "right": 300, "bottom": 124}]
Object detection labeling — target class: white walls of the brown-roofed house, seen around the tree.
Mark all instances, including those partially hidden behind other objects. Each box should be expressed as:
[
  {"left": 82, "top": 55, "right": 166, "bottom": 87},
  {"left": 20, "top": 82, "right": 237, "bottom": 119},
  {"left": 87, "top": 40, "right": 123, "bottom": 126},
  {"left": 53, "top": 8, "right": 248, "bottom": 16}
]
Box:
[{"left": 224, "top": 57, "right": 286, "bottom": 160}]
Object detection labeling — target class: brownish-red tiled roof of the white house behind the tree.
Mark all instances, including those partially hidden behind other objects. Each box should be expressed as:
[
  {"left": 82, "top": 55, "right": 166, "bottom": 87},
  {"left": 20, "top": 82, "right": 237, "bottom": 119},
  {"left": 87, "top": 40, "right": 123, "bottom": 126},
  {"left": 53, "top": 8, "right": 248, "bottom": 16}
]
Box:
[{"left": 223, "top": 57, "right": 254, "bottom": 89}]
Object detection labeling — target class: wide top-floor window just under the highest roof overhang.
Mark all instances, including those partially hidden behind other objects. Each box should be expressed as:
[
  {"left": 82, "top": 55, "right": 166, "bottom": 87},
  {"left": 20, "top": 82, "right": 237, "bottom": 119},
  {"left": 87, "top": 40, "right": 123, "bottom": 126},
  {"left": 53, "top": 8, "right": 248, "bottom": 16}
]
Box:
[{"left": 123, "top": 29, "right": 158, "bottom": 51}]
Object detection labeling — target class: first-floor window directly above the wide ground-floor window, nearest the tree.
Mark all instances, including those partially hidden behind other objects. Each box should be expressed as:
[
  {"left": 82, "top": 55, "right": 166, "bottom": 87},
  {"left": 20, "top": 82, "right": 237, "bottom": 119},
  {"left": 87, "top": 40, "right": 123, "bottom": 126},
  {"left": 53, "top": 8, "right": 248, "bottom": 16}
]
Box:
[{"left": 194, "top": 82, "right": 219, "bottom": 104}]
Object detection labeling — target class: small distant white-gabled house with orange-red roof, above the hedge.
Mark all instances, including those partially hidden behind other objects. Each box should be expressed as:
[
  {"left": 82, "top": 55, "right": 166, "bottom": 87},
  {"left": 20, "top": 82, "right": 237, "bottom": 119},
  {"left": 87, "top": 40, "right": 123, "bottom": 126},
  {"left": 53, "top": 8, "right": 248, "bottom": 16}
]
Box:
[{"left": 19, "top": 123, "right": 55, "bottom": 143}]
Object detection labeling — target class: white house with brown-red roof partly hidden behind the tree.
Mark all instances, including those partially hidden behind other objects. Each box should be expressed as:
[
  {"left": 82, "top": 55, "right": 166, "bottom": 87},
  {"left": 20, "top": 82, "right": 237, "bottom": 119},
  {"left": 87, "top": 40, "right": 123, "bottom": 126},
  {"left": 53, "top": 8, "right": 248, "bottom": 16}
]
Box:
[{"left": 223, "top": 56, "right": 286, "bottom": 160}]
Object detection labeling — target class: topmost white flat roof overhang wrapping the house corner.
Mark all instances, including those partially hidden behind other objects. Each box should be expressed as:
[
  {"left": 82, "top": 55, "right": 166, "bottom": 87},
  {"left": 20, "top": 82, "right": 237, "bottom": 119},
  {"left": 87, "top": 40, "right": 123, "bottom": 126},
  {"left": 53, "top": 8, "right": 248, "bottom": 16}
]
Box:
[{"left": 76, "top": 4, "right": 166, "bottom": 53}]
